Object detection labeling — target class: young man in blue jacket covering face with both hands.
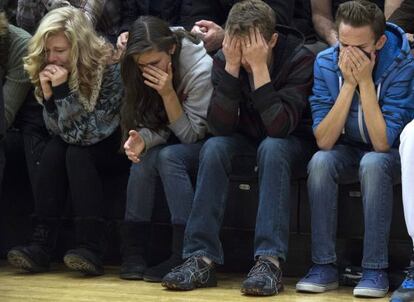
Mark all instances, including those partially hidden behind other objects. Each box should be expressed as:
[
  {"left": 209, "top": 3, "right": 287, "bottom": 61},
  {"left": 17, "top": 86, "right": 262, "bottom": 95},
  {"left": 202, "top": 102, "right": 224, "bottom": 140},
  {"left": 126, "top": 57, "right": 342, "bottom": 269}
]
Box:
[{"left": 296, "top": 0, "right": 414, "bottom": 297}]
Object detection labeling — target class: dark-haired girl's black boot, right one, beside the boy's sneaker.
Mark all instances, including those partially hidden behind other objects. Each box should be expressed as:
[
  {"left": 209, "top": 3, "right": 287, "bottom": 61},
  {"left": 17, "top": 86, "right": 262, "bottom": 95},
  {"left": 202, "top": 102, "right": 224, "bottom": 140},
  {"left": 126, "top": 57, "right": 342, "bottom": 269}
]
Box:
[{"left": 144, "top": 224, "right": 185, "bottom": 282}]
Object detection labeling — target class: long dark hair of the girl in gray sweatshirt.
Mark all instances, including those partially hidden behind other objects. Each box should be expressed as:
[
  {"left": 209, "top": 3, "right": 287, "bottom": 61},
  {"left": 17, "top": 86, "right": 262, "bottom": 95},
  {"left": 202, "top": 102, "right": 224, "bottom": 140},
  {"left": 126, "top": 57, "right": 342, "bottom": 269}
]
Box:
[{"left": 121, "top": 16, "right": 199, "bottom": 139}]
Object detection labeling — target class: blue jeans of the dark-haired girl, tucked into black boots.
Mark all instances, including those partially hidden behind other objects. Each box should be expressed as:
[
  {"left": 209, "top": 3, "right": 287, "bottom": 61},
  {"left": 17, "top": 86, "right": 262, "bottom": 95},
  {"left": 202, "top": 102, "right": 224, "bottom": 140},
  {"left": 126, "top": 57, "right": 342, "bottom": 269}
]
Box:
[{"left": 125, "top": 141, "right": 203, "bottom": 225}]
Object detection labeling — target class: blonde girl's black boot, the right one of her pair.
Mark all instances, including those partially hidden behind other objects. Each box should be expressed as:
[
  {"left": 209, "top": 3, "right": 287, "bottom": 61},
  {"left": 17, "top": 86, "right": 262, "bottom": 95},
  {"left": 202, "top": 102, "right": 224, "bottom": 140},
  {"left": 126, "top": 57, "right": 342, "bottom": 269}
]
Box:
[{"left": 63, "top": 217, "right": 106, "bottom": 276}]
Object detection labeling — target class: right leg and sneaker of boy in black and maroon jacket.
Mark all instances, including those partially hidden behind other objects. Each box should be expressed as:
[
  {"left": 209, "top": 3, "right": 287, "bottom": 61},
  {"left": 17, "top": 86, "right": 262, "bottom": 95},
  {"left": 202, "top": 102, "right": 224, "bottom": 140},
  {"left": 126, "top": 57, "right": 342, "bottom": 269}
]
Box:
[{"left": 242, "top": 136, "right": 316, "bottom": 296}]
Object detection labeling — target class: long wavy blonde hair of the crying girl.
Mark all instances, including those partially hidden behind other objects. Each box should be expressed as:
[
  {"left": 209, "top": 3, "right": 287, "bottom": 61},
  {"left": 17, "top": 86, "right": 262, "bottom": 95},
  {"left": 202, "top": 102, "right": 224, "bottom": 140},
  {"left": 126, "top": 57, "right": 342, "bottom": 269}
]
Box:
[{"left": 23, "top": 7, "right": 113, "bottom": 111}]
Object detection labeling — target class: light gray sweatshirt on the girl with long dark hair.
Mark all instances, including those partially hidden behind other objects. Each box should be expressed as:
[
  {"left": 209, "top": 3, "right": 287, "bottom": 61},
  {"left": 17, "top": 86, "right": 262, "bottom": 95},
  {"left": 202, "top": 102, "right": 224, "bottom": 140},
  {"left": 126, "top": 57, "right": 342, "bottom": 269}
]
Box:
[{"left": 139, "top": 38, "right": 213, "bottom": 150}]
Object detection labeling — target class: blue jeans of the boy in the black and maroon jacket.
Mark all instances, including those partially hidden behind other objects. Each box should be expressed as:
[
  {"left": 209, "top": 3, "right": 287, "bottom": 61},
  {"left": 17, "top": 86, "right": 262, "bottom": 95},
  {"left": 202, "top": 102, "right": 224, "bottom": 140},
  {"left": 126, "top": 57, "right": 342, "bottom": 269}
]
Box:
[{"left": 183, "top": 135, "right": 315, "bottom": 264}]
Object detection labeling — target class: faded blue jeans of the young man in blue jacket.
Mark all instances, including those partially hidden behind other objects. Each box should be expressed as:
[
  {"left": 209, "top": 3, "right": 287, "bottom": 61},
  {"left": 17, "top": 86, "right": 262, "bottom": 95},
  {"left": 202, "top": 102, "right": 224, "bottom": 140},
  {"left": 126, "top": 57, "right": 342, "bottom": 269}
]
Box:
[{"left": 308, "top": 145, "right": 401, "bottom": 269}]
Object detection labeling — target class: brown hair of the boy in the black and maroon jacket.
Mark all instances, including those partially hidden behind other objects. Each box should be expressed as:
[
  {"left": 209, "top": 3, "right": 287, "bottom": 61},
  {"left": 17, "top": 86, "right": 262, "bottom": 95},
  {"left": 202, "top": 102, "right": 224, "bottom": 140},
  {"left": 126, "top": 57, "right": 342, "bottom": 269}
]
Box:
[{"left": 225, "top": 0, "right": 276, "bottom": 41}]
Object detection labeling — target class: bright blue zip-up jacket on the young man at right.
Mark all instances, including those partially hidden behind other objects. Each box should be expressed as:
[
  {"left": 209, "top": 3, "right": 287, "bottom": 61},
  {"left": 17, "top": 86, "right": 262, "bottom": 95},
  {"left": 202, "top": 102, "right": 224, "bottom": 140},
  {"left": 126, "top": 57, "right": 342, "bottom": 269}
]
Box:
[{"left": 309, "top": 23, "right": 414, "bottom": 147}]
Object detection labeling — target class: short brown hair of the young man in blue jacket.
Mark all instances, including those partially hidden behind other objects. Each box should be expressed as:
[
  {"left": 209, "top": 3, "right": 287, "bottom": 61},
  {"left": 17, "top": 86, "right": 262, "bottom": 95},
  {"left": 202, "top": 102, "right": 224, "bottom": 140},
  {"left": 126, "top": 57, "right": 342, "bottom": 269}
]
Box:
[{"left": 335, "top": 0, "right": 385, "bottom": 41}]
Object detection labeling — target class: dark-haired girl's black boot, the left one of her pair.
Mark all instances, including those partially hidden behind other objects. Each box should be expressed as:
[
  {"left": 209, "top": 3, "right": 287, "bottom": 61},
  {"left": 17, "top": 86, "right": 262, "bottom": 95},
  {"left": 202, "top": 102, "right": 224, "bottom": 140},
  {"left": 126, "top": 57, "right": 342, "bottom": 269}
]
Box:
[{"left": 119, "top": 221, "right": 150, "bottom": 280}]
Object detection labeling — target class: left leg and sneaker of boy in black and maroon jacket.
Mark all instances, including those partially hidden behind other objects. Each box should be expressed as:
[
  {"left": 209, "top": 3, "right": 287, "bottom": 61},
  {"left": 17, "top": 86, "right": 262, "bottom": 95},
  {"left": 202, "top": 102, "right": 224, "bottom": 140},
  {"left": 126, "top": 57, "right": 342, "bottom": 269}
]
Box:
[{"left": 163, "top": 136, "right": 256, "bottom": 290}]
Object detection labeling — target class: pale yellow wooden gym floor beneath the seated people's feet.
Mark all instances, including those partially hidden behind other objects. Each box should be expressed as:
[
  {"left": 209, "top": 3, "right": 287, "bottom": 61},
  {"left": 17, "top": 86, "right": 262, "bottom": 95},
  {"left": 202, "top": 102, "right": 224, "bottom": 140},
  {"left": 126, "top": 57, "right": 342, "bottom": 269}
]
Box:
[{"left": 0, "top": 262, "right": 388, "bottom": 302}]
